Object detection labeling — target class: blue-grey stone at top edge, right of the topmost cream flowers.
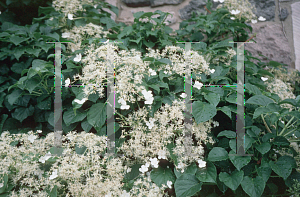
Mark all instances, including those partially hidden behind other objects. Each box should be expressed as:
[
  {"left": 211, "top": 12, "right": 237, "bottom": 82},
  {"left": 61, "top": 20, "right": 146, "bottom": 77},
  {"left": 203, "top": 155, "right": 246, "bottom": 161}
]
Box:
[{"left": 248, "top": 0, "right": 275, "bottom": 21}]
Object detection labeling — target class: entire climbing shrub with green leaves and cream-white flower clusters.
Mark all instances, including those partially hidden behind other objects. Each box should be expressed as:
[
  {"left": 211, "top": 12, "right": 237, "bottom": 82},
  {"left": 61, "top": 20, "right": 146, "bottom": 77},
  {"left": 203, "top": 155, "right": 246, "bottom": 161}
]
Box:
[{"left": 0, "top": 0, "right": 300, "bottom": 197}]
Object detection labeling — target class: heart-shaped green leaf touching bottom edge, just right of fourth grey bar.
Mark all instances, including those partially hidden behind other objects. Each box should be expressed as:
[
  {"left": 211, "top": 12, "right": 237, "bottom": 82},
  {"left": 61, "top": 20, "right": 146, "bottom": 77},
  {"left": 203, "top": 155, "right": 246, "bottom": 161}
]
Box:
[{"left": 241, "top": 176, "right": 266, "bottom": 197}]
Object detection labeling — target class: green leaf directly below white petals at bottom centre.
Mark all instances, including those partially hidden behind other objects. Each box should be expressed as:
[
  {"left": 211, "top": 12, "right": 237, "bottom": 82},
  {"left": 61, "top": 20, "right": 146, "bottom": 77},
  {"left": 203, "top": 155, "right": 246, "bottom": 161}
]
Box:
[{"left": 150, "top": 166, "right": 176, "bottom": 187}]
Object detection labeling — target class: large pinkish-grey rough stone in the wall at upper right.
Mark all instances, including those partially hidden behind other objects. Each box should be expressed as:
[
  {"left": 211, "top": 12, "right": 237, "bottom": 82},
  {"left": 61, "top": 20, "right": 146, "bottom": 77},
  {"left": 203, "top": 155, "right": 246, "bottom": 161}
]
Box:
[{"left": 245, "top": 23, "right": 292, "bottom": 66}]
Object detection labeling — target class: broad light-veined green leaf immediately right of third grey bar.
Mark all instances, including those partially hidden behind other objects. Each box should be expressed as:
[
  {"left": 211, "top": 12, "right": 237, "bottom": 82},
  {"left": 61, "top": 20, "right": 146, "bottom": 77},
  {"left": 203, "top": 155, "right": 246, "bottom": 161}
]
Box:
[{"left": 192, "top": 101, "right": 217, "bottom": 124}]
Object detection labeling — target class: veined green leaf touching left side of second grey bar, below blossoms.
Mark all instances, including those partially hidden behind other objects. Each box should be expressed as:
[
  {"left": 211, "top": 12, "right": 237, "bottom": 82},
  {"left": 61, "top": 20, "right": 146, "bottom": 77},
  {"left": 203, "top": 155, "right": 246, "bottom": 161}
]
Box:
[{"left": 87, "top": 103, "right": 106, "bottom": 131}]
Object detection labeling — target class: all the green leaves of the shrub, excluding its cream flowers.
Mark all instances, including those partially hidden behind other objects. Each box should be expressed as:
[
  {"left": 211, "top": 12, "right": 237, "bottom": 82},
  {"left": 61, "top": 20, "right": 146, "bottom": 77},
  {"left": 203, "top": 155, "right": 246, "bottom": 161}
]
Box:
[{"left": 0, "top": 0, "right": 300, "bottom": 197}]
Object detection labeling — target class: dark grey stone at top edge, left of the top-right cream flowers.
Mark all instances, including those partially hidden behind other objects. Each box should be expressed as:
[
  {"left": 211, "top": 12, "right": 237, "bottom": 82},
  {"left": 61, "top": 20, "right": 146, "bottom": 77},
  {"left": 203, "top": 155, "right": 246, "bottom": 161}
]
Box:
[{"left": 179, "top": 0, "right": 207, "bottom": 20}]
